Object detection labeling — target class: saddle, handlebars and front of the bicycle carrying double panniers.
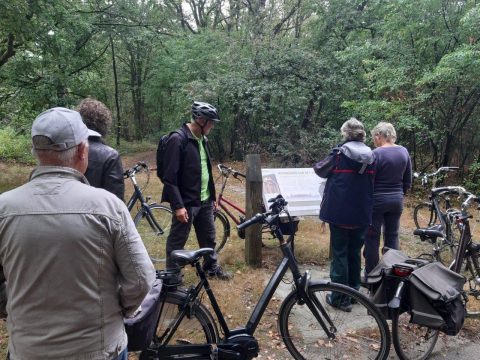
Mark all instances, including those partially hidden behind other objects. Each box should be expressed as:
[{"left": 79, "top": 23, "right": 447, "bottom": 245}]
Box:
[{"left": 414, "top": 191, "right": 480, "bottom": 317}]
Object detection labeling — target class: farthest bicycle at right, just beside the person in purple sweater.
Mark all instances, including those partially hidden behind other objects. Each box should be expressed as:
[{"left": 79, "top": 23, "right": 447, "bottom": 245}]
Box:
[{"left": 413, "top": 166, "right": 459, "bottom": 229}]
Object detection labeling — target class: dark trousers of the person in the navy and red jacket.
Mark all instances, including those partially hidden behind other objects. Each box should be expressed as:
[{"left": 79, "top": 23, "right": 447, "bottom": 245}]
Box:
[{"left": 330, "top": 224, "right": 368, "bottom": 301}]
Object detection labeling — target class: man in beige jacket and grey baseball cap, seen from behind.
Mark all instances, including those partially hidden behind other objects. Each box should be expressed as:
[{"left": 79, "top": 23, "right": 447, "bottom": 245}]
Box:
[{"left": 0, "top": 108, "right": 155, "bottom": 360}]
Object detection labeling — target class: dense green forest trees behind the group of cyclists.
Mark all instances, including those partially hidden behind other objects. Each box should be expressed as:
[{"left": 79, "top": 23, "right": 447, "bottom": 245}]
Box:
[{"left": 0, "top": 0, "right": 480, "bottom": 190}]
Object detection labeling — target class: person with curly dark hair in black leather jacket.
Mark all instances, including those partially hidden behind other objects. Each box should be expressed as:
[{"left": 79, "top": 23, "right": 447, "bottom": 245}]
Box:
[{"left": 77, "top": 98, "right": 125, "bottom": 201}]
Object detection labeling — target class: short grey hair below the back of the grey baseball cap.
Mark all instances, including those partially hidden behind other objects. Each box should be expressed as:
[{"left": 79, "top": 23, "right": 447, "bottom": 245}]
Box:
[{"left": 32, "top": 135, "right": 88, "bottom": 168}]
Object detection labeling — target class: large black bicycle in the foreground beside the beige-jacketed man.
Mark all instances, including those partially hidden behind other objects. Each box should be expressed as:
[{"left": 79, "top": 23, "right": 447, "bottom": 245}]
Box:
[{"left": 140, "top": 196, "right": 390, "bottom": 360}]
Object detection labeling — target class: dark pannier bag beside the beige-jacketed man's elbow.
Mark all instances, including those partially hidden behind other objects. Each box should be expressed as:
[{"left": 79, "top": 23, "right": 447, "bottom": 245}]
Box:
[{"left": 123, "top": 279, "right": 162, "bottom": 351}]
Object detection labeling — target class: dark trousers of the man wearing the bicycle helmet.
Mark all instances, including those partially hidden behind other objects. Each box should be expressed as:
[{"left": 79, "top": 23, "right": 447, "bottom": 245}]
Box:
[{"left": 166, "top": 202, "right": 217, "bottom": 269}]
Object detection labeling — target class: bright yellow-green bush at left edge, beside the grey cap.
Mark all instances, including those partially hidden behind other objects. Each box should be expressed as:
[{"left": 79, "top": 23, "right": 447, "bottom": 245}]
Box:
[{"left": 0, "top": 126, "right": 35, "bottom": 163}]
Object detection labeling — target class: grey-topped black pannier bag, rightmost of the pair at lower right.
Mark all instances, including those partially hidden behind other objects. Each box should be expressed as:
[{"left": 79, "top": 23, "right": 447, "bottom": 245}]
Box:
[{"left": 409, "top": 262, "right": 465, "bottom": 335}]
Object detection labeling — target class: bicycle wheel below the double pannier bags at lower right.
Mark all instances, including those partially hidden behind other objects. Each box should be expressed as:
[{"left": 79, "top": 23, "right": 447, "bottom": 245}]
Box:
[{"left": 392, "top": 311, "right": 439, "bottom": 360}]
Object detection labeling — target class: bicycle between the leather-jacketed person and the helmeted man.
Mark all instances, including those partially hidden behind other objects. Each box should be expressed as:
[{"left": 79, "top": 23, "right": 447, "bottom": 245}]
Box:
[{"left": 123, "top": 162, "right": 172, "bottom": 266}]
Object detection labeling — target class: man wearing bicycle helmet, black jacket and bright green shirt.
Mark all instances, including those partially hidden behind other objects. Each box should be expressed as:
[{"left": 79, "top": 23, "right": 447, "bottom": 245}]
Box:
[{"left": 162, "top": 101, "right": 231, "bottom": 280}]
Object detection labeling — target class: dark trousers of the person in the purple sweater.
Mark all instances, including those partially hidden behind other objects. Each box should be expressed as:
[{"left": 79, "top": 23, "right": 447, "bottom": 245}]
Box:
[{"left": 363, "top": 193, "right": 403, "bottom": 274}]
